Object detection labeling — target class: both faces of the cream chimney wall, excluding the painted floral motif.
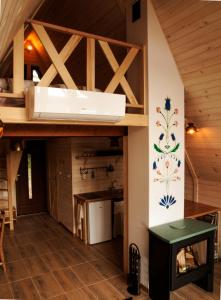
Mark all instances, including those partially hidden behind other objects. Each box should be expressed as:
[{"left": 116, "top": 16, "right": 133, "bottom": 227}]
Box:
[{"left": 127, "top": 0, "right": 184, "bottom": 287}]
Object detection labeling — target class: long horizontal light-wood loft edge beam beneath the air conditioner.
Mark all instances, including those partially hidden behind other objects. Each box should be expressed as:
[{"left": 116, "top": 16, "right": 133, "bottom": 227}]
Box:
[{"left": 0, "top": 107, "right": 148, "bottom": 127}]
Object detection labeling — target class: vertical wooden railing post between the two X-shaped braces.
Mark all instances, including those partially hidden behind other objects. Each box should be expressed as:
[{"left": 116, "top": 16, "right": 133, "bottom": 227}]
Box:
[{"left": 87, "top": 38, "right": 95, "bottom": 91}]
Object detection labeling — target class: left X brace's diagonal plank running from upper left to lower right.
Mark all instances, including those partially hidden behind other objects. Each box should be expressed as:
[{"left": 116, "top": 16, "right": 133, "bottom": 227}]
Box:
[{"left": 32, "top": 24, "right": 77, "bottom": 89}]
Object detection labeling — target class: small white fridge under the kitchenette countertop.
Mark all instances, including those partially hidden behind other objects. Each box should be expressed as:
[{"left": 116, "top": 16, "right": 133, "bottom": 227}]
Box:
[{"left": 88, "top": 200, "right": 112, "bottom": 244}]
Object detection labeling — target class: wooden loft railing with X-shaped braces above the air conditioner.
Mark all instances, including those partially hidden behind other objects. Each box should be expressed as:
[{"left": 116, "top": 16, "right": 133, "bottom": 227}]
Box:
[{"left": 28, "top": 20, "right": 146, "bottom": 109}]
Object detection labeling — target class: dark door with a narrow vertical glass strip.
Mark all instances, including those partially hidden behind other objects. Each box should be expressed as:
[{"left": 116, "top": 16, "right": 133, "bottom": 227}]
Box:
[{"left": 16, "top": 140, "right": 47, "bottom": 216}]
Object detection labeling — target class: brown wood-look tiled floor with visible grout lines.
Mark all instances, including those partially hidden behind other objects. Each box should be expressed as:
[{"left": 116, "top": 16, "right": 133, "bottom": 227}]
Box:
[{"left": 0, "top": 214, "right": 221, "bottom": 300}]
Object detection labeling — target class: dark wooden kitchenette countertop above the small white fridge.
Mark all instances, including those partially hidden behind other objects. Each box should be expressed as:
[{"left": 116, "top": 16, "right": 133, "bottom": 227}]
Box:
[{"left": 74, "top": 189, "right": 123, "bottom": 202}]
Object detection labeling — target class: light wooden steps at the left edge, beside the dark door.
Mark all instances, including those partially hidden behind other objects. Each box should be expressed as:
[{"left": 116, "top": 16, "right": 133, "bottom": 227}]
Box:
[{"left": 0, "top": 151, "right": 22, "bottom": 230}]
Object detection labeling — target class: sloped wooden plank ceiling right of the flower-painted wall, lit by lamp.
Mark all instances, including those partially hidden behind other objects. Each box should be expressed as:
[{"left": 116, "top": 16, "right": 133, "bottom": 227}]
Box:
[{"left": 153, "top": 0, "right": 221, "bottom": 181}]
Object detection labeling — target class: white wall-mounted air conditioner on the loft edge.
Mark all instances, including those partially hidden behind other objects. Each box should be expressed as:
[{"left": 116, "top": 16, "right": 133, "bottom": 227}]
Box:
[{"left": 26, "top": 87, "right": 126, "bottom": 122}]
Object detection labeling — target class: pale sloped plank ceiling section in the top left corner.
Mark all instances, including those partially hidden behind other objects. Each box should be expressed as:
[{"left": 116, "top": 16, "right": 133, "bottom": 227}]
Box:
[{"left": 0, "top": 0, "right": 43, "bottom": 61}]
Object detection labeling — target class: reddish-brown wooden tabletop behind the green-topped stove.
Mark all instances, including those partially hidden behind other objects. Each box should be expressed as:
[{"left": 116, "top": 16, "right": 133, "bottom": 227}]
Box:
[{"left": 184, "top": 200, "right": 220, "bottom": 218}]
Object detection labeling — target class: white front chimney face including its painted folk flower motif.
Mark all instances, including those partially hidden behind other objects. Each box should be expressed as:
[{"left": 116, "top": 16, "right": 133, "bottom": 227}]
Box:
[{"left": 148, "top": 1, "right": 185, "bottom": 227}]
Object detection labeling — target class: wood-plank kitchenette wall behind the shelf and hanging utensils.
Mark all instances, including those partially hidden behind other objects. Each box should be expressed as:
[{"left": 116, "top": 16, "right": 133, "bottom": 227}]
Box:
[{"left": 72, "top": 137, "right": 123, "bottom": 194}]
